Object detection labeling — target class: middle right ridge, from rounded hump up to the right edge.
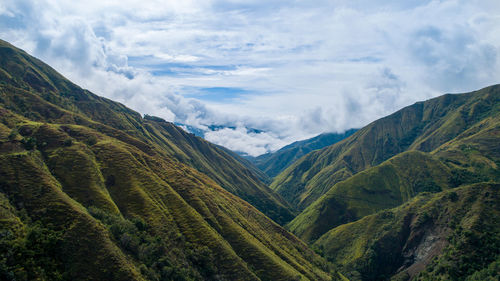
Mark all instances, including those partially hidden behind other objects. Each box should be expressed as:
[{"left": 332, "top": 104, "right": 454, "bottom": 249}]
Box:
[{"left": 289, "top": 92, "right": 500, "bottom": 241}]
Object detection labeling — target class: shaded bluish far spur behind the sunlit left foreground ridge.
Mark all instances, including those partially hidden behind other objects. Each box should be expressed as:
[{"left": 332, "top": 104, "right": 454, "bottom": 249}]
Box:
[{"left": 140, "top": 116, "right": 293, "bottom": 224}]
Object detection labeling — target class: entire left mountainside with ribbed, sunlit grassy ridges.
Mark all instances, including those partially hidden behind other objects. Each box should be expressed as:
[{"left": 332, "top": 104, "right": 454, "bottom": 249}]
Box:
[{"left": 0, "top": 38, "right": 331, "bottom": 280}]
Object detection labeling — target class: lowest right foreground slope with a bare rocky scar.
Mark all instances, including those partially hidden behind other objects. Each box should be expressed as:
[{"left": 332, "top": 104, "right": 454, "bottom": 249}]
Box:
[{"left": 314, "top": 183, "right": 500, "bottom": 280}]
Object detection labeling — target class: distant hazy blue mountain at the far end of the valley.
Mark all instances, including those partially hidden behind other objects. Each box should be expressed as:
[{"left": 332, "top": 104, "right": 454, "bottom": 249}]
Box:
[{"left": 247, "top": 129, "right": 356, "bottom": 178}]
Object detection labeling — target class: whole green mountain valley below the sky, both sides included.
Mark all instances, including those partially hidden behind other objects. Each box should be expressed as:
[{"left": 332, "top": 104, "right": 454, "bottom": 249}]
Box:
[{"left": 0, "top": 37, "right": 500, "bottom": 280}]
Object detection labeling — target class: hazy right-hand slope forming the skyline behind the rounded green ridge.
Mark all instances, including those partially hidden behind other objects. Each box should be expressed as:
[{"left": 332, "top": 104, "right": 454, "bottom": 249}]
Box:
[{"left": 271, "top": 85, "right": 500, "bottom": 209}]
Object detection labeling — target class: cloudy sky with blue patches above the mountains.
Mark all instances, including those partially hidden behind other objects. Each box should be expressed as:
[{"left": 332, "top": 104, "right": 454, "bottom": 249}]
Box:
[{"left": 0, "top": 0, "right": 500, "bottom": 156}]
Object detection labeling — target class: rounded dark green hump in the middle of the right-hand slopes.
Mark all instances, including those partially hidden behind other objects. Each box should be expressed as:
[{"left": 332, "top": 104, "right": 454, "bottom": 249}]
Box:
[{"left": 288, "top": 152, "right": 458, "bottom": 241}]
